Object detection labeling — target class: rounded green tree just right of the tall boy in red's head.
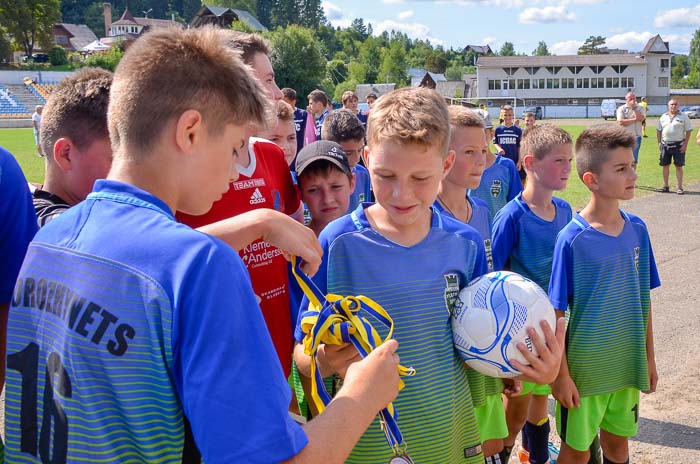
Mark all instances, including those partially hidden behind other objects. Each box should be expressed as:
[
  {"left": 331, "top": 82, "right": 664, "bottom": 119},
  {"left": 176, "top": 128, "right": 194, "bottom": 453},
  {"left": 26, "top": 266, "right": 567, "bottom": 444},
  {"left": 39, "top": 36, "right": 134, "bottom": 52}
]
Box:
[{"left": 265, "top": 25, "right": 332, "bottom": 105}]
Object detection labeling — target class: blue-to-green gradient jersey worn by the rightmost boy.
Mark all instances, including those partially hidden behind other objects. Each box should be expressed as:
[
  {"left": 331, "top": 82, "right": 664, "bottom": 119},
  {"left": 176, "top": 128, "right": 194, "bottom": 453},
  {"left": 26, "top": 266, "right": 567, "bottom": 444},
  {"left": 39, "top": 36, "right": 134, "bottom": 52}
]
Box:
[{"left": 549, "top": 211, "right": 661, "bottom": 396}]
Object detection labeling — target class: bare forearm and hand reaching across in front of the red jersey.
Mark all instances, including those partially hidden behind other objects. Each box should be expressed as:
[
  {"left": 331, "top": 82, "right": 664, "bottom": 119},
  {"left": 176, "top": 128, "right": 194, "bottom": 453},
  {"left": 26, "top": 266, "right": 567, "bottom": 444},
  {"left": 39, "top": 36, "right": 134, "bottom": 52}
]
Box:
[{"left": 197, "top": 209, "right": 323, "bottom": 275}]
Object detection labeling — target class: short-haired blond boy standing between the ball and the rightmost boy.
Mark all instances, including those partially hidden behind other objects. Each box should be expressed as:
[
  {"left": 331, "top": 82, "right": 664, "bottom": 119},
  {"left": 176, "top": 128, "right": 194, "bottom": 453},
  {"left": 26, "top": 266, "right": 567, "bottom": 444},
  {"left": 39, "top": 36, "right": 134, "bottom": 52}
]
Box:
[{"left": 493, "top": 124, "right": 573, "bottom": 464}]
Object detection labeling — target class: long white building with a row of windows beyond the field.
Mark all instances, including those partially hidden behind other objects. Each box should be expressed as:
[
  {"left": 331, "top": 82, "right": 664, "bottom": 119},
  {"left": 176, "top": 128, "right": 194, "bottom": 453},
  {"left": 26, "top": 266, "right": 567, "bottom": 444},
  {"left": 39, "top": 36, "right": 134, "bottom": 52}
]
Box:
[{"left": 476, "top": 35, "right": 671, "bottom": 117}]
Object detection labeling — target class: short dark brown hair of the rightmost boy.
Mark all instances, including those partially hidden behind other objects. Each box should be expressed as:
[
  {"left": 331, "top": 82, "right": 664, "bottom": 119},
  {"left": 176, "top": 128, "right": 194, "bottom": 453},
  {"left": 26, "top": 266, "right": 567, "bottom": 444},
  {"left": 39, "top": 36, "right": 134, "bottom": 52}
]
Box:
[{"left": 576, "top": 124, "right": 637, "bottom": 180}]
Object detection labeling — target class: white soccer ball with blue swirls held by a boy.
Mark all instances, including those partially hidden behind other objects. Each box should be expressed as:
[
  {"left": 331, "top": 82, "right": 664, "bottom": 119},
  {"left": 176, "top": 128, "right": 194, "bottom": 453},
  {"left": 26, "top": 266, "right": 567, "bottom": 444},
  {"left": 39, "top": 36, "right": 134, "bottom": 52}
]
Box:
[{"left": 452, "top": 271, "right": 556, "bottom": 378}]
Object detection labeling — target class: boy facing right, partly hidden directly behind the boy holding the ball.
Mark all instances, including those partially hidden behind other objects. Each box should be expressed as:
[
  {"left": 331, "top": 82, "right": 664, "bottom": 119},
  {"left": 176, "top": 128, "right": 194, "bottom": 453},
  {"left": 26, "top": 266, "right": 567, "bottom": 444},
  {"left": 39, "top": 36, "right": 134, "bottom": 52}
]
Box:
[{"left": 433, "top": 106, "right": 519, "bottom": 464}]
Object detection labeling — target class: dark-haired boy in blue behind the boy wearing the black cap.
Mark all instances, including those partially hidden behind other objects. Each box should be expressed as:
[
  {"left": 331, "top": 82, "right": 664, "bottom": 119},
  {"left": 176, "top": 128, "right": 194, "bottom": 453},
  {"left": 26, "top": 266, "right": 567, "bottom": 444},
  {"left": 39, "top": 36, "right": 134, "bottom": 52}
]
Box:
[{"left": 321, "top": 110, "right": 372, "bottom": 213}]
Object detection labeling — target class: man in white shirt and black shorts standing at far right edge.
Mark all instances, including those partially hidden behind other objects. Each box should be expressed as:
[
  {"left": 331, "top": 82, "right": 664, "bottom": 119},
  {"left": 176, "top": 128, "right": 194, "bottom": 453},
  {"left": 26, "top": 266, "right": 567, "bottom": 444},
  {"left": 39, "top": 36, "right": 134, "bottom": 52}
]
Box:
[{"left": 656, "top": 100, "right": 693, "bottom": 195}]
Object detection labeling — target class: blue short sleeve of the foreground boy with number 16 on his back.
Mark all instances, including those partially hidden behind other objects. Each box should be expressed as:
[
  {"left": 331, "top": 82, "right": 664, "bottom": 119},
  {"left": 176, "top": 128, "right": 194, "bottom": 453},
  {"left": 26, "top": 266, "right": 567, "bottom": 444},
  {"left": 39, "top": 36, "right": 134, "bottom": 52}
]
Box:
[{"left": 173, "top": 243, "right": 307, "bottom": 463}]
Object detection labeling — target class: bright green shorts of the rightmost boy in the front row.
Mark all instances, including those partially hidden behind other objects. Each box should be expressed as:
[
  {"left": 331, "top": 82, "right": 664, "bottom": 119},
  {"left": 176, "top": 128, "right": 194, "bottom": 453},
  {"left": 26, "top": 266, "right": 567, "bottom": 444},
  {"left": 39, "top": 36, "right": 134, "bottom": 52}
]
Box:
[{"left": 556, "top": 388, "right": 639, "bottom": 451}]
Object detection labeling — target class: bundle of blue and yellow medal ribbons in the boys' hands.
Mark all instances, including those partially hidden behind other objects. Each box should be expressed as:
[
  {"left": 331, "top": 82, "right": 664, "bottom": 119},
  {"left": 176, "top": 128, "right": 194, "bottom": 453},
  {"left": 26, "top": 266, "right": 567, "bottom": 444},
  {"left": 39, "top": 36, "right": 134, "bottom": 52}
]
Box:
[{"left": 292, "top": 256, "right": 416, "bottom": 453}]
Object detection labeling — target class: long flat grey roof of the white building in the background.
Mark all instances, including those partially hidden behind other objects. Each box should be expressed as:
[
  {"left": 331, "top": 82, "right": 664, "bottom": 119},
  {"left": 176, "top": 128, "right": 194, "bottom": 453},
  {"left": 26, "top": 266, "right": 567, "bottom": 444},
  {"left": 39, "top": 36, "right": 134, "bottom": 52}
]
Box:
[{"left": 476, "top": 54, "right": 646, "bottom": 68}]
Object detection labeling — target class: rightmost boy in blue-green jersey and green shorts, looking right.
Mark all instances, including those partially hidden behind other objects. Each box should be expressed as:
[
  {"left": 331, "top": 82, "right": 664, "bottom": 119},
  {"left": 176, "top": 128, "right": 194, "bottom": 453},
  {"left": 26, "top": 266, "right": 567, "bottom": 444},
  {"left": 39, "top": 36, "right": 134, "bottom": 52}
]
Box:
[{"left": 549, "top": 125, "right": 660, "bottom": 464}]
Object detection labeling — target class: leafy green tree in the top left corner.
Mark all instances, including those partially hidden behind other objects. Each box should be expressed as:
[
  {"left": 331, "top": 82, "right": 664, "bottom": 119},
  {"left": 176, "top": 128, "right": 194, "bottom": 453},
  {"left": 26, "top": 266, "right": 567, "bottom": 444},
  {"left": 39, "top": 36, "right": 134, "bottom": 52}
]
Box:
[{"left": 0, "top": 0, "right": 61, "bottom": 56}]
